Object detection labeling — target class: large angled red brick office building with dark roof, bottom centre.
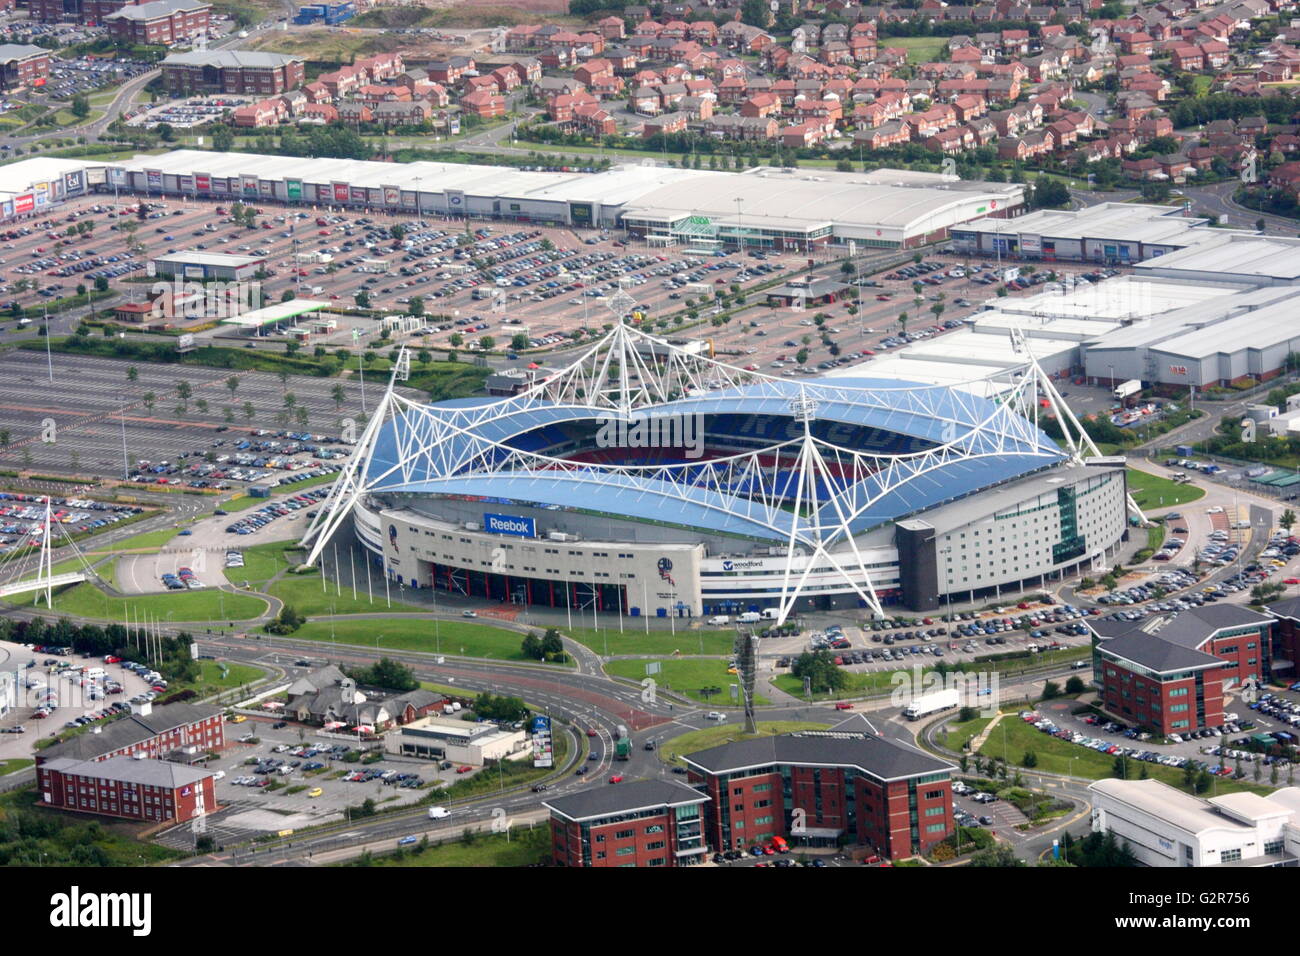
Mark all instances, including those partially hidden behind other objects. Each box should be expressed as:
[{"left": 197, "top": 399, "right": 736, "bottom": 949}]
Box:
[{"left": 683, "top": 731, "right": 953, "bottom": 858}]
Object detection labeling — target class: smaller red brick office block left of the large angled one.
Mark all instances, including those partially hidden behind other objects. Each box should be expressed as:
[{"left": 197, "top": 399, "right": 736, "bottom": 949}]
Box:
[{"left": 542, "top": 780, "right": 709, "bottom": 866}]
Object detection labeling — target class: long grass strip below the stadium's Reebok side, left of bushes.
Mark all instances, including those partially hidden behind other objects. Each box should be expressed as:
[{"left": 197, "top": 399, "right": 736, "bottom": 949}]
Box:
[{"left": 293, "top": 618, "right": 556, "bottom": 661}]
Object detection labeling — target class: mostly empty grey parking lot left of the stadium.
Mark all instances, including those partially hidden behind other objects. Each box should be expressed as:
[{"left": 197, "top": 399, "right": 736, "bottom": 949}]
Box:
[{"left": 0, "top": 350, "right": 431, "bottom": 488}]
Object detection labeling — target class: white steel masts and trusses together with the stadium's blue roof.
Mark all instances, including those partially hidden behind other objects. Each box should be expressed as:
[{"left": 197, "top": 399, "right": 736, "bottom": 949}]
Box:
[{"left": 303, "top": 321, "right": 1140, "bottom": 622}]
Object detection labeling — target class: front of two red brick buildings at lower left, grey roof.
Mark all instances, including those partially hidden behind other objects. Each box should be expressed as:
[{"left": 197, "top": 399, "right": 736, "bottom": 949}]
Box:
[{"left": 36, "top": 757, "right": 217, "bottom": 823}]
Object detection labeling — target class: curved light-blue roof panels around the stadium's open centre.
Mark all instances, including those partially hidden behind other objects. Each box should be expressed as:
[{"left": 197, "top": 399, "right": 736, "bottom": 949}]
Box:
[{"left": 367, "top": 378, "right": 1063, "bottom": 540}]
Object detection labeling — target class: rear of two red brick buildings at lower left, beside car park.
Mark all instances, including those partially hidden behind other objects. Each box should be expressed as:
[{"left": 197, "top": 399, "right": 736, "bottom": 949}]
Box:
[{"left": 35, "top": 704, "right": 226, "bottom": 767}]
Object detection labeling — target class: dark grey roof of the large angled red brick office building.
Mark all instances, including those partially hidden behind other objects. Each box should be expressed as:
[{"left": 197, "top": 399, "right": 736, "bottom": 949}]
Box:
[{"left": 683, "top": 731, "right": 953, "bottom": 780}]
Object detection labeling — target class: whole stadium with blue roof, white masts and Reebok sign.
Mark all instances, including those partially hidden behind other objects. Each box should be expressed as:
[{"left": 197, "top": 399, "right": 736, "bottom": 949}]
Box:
[{"left": 303, "top": 324, "right": 1131, "bottom": 620}]
